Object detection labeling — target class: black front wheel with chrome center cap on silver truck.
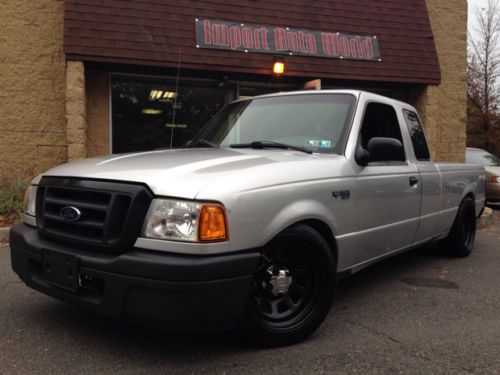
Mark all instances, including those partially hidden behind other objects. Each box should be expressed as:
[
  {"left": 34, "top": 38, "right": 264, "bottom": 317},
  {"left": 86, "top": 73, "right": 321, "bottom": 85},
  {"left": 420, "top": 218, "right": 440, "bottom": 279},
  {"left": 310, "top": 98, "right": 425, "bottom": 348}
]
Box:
[{"left": 242, "top": 224, "right": 336, "bottom": 346}]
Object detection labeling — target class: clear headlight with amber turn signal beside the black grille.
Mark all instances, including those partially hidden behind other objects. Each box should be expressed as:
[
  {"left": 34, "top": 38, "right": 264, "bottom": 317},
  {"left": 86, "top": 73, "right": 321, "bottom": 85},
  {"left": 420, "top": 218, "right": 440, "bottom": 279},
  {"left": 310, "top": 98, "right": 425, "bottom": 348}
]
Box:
[{"left": 142, "top": 198, "right": 227, "bottom": 242}]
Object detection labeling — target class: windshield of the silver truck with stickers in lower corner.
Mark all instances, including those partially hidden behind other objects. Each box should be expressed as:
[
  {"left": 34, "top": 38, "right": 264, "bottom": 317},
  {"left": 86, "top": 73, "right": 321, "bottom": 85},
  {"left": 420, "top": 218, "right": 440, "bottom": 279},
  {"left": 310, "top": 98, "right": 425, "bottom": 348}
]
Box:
[{"left": 191, "top": 93, "right": 355, "bottom": 153}]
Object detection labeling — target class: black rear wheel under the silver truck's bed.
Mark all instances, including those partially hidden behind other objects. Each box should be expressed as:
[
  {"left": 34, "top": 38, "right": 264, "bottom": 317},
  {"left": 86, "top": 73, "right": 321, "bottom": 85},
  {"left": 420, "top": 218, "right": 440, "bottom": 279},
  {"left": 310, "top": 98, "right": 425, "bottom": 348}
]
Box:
[{"left": 440, "top": 197, "right": 476, "bottom": 258}]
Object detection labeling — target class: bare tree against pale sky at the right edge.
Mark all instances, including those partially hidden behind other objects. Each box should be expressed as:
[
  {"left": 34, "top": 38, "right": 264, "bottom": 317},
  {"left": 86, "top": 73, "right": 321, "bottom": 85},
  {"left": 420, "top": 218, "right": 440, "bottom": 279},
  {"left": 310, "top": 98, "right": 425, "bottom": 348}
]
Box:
[{"left": 467, "top": 0, "right": 500, "bottom": 150}]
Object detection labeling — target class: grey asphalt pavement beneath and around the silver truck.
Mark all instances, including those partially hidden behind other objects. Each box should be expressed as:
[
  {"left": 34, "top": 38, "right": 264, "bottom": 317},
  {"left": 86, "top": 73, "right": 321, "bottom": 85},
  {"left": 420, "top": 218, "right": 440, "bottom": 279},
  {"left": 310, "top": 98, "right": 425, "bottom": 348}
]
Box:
[{"left": 0, "top": 207, "right": 500, "bottom": 375}]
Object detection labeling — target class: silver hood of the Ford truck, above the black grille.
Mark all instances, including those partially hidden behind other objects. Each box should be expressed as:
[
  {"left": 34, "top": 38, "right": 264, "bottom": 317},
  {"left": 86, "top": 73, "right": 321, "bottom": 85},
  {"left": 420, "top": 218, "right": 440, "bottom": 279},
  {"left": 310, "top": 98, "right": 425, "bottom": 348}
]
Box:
[{"left": 39, "top": 148, "right": 340, "bottom": 199}]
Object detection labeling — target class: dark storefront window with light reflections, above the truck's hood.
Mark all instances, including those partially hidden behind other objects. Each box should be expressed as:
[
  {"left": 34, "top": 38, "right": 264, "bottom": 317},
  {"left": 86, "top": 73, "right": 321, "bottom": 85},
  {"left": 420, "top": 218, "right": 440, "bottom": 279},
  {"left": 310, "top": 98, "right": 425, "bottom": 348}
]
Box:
[{"left": 111, "top": 77, "right": 235, "bottom": 153}]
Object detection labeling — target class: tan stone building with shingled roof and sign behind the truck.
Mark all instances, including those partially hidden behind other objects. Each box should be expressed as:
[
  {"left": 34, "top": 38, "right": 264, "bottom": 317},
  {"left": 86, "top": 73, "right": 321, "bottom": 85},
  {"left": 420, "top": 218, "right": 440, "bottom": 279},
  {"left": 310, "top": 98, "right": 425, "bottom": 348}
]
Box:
[{"left": 0, "top": 0, "right": 467, "bottom": 178}]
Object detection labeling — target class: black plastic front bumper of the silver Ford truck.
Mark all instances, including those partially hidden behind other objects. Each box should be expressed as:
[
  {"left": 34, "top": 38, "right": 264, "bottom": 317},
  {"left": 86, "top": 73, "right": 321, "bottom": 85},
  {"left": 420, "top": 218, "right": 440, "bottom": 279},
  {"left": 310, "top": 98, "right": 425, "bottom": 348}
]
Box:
[{"left": 10, "top": 224, "right": 260, "bottom": 331}]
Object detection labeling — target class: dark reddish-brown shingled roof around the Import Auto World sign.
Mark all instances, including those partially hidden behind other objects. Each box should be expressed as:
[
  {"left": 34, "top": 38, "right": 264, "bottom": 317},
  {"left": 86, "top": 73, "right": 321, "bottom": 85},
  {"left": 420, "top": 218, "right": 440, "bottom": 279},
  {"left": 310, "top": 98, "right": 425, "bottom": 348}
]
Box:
[{"left": 64, "top": 0, "right": 440, "bottom": 84}]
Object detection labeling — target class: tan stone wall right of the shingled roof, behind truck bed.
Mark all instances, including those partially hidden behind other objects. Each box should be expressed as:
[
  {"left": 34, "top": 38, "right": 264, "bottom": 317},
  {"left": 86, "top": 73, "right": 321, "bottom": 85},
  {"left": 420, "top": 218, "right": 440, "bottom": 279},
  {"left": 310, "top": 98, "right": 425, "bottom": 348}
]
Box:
[{"left": 420, "top": 0, "right": 467, "bottom": 162}]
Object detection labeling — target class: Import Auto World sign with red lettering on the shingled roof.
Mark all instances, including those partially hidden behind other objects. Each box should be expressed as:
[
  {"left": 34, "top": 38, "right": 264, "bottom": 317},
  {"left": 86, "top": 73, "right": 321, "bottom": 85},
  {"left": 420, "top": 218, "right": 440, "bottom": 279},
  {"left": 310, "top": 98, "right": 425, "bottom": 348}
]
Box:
[{"left": 195, "top": 19, "right": 381, "bottom": 61}]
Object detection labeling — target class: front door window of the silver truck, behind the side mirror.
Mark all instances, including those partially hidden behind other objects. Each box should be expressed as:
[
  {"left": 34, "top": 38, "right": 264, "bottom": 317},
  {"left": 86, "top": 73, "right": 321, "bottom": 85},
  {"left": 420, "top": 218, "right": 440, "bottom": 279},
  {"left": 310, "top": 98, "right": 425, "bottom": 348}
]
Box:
[{"left": 358, "top": 102, "right": 406, "bottom": 162}]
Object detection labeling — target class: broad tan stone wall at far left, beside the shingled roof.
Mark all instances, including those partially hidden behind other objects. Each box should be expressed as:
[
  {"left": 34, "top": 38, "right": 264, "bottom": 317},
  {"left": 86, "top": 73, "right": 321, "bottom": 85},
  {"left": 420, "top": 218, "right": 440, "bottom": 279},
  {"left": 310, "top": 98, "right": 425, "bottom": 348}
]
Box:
[{"left": 0, "top": 0, "right": 67, "bottom": 176}]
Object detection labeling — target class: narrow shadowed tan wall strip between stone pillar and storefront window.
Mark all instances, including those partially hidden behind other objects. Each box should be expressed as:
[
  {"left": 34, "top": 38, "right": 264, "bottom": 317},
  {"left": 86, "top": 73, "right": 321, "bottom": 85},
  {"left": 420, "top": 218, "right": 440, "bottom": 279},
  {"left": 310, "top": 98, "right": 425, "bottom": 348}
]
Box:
[{"left": 85, "top": 70, "right": 110, "bottom": 157}]
